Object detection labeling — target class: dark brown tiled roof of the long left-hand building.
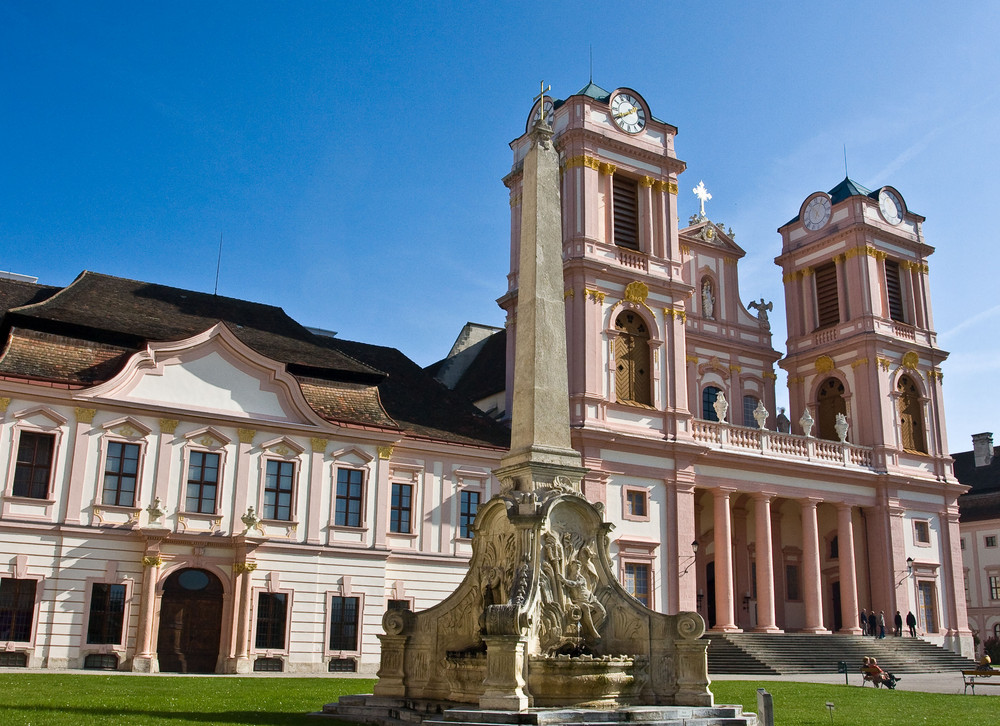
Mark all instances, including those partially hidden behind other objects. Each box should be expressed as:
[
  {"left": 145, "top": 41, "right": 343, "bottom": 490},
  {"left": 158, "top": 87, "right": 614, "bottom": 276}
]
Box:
[{"left": 0, "top": 272, "right": 509, "bottom": 447}]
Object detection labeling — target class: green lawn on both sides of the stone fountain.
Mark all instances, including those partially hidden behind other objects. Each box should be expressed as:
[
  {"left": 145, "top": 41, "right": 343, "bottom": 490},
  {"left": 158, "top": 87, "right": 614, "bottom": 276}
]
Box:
[{"left": 0, "top": 671, "right": 1000, "bottom": 726}]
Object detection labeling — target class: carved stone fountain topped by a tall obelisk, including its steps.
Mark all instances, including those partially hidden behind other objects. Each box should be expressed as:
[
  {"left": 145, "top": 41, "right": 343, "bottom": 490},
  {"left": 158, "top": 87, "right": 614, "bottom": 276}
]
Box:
[{"left": 326, "top": 99, "right": 754, "bottom": 724}]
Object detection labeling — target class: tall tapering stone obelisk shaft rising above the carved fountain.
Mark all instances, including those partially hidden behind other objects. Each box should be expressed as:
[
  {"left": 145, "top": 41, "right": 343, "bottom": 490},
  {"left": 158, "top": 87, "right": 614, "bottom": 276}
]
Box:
[{"left": 496, "top": 106, "right": 586, "bottom": 491}]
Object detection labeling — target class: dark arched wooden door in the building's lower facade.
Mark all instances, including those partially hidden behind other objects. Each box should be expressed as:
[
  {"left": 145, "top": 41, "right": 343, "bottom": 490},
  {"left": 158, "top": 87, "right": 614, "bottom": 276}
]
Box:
[{"left": 156, "top": 568, "right": 223, "bottom": 673}]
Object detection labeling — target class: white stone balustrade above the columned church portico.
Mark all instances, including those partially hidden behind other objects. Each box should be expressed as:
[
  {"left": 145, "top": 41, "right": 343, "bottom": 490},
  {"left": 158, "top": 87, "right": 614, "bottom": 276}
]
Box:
[{"left": 691, "top": 419, "right": 872, "bottom": 469}]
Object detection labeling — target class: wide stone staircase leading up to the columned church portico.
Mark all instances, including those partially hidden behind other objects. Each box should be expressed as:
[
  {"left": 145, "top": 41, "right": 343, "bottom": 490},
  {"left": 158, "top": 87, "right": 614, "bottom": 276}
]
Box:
[{"left": 705, "top": 633, "right": 975, "bottom": 675}]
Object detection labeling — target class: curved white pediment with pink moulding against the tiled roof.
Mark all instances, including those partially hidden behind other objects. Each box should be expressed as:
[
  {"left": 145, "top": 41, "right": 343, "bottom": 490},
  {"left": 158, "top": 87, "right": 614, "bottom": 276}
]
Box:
[{"left": 78, "top": 323, "right": 324, "bottom": 430}]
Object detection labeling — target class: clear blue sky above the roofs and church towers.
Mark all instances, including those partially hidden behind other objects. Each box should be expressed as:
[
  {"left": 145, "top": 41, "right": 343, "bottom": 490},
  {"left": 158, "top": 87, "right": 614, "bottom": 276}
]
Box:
[{"left": 0, "top": 0, "right": 1000, "bottom": 451}]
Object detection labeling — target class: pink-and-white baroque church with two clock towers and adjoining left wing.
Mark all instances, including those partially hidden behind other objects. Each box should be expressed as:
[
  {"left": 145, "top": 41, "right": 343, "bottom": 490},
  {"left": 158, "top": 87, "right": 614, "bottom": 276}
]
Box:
[{"left": 0, "top": 83, "right": 972, "bottom": 673}]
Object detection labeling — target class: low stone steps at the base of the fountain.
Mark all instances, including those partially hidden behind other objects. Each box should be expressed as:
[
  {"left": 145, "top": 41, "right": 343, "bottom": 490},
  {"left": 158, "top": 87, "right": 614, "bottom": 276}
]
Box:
[{"left": 324, "top": 696, "right": 757, "bottom": 726}]
